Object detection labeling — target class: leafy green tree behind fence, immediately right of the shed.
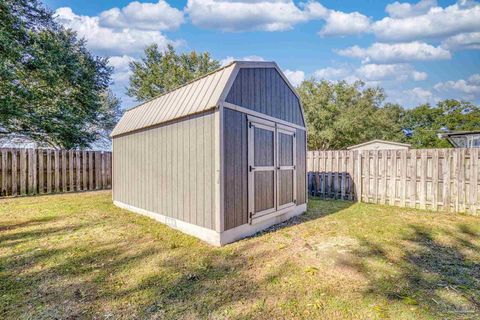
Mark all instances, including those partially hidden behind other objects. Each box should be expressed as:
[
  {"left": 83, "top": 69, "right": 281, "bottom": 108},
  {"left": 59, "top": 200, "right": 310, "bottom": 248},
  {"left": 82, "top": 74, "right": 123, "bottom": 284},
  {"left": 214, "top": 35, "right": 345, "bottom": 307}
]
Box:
[{"left": 298, "top": 79, "right": 404, "bottom": 150}]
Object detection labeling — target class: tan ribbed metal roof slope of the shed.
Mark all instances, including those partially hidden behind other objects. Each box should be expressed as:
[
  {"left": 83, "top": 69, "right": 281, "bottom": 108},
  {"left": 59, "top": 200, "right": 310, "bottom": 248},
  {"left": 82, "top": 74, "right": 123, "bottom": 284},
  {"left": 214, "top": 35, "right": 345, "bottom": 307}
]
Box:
[{"left": 111, "top": 62, "right": 237, "bottom": 137}]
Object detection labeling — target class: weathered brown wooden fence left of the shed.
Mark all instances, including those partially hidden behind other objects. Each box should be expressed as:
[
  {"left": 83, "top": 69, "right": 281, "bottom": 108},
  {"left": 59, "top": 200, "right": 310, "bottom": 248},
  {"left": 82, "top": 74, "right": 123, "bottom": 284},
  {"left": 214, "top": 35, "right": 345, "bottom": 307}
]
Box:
[{"left": 0, "top": 148, "right": 112, "bottom": 197}]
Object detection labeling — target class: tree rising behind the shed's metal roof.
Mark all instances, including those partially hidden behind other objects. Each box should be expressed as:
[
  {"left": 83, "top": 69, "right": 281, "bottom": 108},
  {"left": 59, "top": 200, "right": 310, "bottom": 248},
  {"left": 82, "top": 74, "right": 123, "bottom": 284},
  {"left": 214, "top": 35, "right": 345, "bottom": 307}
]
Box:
[{"left": 127, "top": 44, "right": 220, "bottom": 101}]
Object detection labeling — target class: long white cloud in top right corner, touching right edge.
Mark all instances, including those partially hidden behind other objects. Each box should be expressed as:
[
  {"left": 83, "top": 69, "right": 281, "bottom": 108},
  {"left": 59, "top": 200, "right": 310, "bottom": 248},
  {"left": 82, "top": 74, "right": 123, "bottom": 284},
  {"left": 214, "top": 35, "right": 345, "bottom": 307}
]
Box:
[{"left": 372, "top": 1, "right": 480, "bottom": 41}]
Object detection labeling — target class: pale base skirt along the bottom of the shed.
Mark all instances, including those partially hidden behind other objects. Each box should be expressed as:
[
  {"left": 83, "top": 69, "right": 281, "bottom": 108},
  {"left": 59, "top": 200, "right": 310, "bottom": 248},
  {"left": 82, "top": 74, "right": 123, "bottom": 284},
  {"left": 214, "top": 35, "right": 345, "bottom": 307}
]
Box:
[{"left": 113, "top": 201, "right": 307, "bottom": 246}]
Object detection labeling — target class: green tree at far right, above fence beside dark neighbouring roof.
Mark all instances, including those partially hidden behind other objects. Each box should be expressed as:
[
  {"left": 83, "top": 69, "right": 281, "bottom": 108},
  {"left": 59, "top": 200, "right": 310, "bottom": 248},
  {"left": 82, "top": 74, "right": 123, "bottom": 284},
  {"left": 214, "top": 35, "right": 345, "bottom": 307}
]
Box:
[{"left": 402, "top": 99, "right": 480, "bottom": 148}]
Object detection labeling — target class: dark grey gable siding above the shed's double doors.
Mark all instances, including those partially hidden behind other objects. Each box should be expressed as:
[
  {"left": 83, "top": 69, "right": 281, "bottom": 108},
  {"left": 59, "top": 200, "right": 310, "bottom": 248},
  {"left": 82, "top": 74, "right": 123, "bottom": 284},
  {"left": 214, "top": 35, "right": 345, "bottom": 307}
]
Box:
[{"left": 225, "top": 68, "right": 305, "bottom": 127}]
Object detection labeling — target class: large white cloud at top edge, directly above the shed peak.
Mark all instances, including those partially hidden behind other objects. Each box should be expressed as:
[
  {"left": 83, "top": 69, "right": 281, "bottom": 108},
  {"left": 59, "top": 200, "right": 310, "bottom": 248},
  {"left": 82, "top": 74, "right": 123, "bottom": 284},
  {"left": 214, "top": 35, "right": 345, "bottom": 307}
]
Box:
[{"left": 185, "top": 0, "right": 308, "bottom": 32}]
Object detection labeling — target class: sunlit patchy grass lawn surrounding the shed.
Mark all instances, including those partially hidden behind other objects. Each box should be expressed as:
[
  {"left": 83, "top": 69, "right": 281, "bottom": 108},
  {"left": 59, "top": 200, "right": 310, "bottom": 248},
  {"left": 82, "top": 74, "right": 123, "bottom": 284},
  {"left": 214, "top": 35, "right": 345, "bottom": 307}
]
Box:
[{"left": 0, "top": 192, "right": 480, "bottom": 320}]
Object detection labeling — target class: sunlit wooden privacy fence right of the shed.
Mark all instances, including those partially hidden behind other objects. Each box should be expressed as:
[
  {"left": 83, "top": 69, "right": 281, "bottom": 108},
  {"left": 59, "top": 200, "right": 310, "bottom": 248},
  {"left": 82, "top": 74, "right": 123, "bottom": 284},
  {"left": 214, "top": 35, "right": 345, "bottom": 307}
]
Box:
[{"left": 307, "top": 148, "right": 480, "bottom": 214}]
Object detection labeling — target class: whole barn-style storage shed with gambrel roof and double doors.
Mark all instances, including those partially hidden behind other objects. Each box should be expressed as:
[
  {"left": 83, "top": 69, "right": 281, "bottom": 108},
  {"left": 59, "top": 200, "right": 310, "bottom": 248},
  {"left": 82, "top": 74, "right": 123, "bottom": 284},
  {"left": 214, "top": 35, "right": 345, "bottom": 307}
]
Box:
[{"left": 112, "top": 61, "right": 307, "bottom": 245}]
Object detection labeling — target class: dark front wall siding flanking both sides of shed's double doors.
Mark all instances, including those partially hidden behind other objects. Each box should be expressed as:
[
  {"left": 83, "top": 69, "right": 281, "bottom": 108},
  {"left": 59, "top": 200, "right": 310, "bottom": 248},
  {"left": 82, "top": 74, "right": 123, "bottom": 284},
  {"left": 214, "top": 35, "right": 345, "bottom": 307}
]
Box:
[{"left": 223, "top": 108, "right": 306, "bottom": 230}]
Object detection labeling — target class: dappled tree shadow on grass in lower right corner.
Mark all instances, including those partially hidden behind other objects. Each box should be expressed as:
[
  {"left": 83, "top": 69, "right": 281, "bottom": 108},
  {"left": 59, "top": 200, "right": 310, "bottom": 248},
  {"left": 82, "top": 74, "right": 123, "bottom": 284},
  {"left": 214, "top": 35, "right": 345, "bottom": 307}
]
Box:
[{"left": 341, "top": 224, "right": 480, "bottom": 319}]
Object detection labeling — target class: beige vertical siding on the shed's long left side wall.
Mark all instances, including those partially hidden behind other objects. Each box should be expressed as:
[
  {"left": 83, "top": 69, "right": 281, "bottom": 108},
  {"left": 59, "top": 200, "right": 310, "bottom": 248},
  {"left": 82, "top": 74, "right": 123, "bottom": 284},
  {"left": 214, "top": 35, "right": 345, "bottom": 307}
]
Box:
[{"left": 113, "top": 112, "right": 216, "bottom": 230}]
